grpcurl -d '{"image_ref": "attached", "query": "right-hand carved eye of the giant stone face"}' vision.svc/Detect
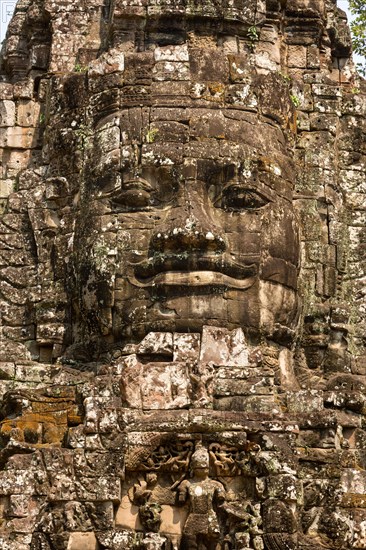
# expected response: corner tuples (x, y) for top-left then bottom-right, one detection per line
(215, 183), (269, 212)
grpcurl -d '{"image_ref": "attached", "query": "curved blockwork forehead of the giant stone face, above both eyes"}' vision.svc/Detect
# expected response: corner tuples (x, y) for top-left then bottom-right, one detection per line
(87, 106), (294, 204)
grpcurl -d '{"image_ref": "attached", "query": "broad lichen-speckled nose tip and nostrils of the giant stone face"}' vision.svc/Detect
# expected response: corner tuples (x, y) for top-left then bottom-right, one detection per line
(150, 215), (226, 256)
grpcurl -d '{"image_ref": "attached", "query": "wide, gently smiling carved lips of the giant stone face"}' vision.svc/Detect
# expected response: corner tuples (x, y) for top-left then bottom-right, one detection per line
(128, 254), (258, 290)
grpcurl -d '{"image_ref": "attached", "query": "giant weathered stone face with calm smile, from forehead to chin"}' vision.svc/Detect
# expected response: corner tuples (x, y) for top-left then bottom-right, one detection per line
(67, 59), (299, 350)
